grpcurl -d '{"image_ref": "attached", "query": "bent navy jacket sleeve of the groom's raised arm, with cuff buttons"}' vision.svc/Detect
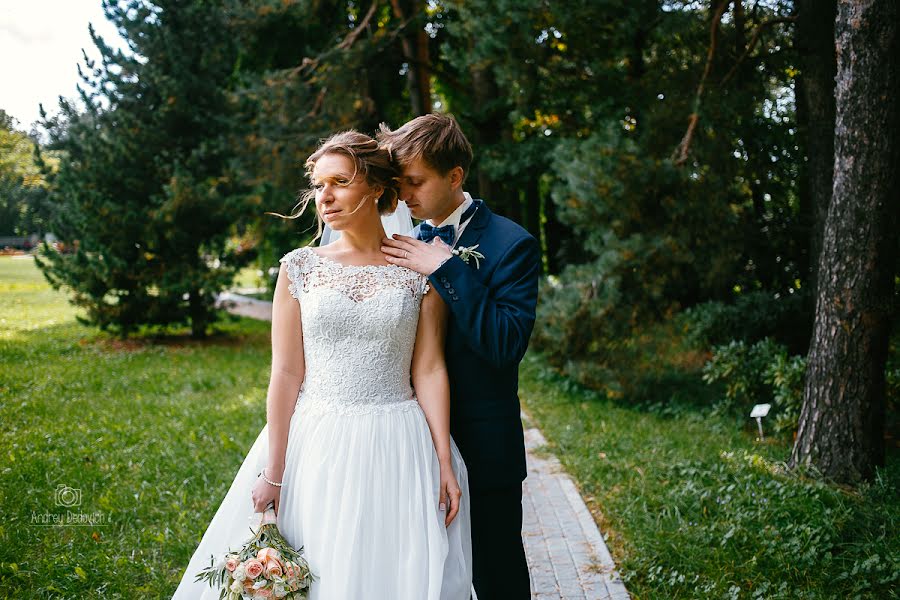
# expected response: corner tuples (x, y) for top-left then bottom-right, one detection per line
(429, 236), (541, 367)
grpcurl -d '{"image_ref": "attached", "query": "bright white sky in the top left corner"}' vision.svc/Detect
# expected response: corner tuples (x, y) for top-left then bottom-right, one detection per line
(0, 0), (124, 131)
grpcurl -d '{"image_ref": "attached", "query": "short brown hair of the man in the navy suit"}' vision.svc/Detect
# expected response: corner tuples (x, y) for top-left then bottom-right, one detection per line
(376, 113), (472, 181)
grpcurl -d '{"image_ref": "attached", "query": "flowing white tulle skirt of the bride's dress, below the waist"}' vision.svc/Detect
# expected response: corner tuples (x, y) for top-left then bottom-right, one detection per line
(173, 399), (472, 600)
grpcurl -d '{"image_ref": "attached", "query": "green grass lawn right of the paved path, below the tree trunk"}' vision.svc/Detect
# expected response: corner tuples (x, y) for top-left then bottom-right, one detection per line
(521, 355), (900, 599)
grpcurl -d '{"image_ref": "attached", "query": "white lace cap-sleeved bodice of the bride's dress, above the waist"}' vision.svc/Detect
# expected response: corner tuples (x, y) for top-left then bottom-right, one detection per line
(280, 248), (428, 413)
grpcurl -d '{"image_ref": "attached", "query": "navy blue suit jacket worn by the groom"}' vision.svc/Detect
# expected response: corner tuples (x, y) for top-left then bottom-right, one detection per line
(413, 200), (541, 489)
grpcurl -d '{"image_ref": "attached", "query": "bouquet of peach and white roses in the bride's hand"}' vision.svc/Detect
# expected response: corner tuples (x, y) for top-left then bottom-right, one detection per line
(196, 508), (314, 600)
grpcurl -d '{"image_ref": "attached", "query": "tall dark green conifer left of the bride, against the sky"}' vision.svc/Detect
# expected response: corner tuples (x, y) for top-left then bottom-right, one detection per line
(38, 0), (252, 337)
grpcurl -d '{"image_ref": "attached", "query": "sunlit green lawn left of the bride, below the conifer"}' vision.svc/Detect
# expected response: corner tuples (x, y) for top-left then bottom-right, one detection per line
(0, 257), (269, 598)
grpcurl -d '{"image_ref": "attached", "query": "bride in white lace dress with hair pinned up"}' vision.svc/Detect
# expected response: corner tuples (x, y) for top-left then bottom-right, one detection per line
(174, 131), (472, 600)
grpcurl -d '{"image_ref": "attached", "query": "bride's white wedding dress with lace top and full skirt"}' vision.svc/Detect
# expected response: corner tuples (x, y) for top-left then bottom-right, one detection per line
(174, 248), (472, 600)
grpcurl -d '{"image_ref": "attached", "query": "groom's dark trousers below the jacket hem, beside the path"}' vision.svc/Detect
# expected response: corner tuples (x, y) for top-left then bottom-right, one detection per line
(469, 483), (531, 600)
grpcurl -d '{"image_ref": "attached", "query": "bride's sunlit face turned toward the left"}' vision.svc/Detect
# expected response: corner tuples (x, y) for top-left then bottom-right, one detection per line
(312, 154), (381, 231)
